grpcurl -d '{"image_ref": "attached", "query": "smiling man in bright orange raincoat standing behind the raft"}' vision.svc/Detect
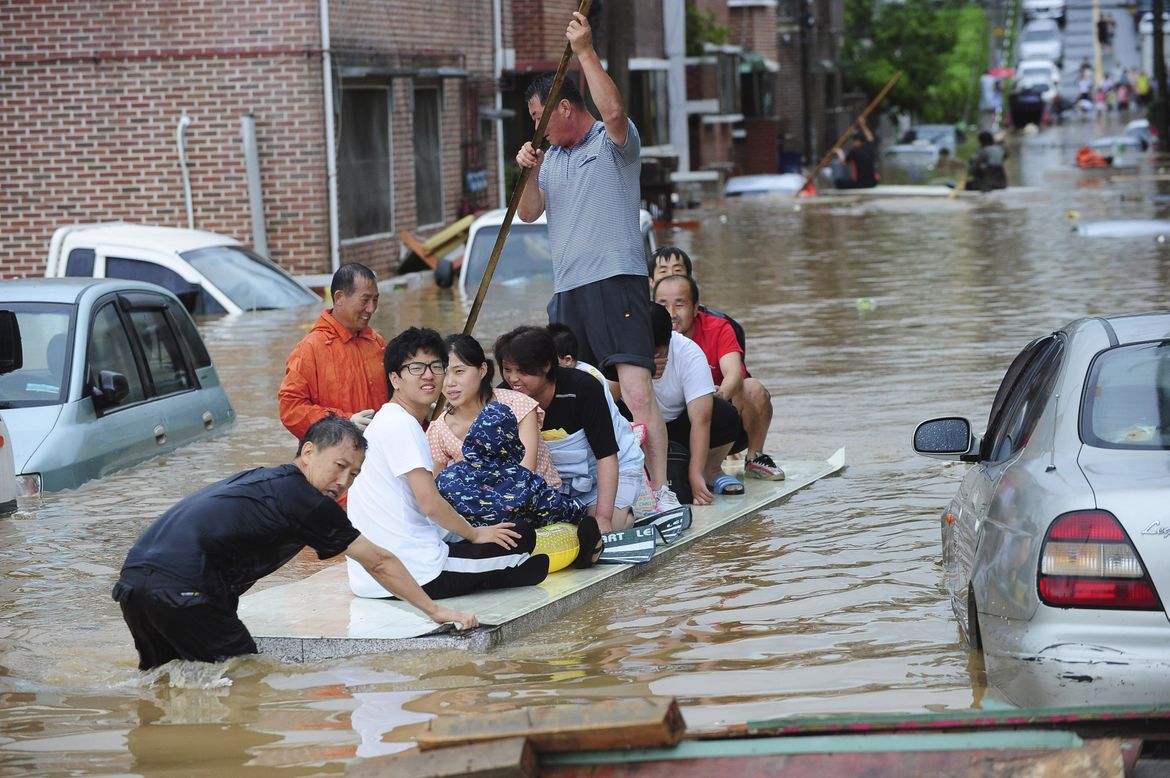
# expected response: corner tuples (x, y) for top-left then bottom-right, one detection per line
(277, 262), (390, 440)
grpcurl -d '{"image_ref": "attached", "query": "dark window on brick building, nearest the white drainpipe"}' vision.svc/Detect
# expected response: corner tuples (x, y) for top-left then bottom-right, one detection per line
(337, 87), (393, 239)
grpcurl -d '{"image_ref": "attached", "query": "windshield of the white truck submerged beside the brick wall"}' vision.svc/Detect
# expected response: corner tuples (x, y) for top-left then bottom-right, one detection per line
(183, 246), (321, 311)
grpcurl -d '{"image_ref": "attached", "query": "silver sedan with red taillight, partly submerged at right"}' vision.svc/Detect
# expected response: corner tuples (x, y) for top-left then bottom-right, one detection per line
(914, 314), (1170, 704)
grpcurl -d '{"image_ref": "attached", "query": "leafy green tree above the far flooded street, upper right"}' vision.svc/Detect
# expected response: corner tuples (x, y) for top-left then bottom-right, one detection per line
(841, 0), (987, 122)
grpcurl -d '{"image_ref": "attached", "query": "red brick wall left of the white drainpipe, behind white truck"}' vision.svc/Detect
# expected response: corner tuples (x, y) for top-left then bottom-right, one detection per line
(0, 0), (328, 277)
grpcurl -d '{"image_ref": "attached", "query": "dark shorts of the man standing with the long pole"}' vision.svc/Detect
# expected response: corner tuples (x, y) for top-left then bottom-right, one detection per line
(549, 276), (654, 380)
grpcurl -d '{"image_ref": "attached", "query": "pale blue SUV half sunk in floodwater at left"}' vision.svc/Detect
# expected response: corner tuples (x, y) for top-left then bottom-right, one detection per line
(0, 278), (235, 496)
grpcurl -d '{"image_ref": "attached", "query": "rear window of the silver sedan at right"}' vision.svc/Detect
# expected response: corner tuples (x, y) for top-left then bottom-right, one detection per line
(1081, 342), (1170, 449)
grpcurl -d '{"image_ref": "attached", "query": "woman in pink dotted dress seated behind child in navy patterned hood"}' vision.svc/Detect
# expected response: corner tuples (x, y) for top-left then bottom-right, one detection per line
(427, 335), (560, 489)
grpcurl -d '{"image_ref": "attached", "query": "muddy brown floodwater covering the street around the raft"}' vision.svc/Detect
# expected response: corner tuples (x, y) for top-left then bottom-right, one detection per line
(0, 115), (1170, 776)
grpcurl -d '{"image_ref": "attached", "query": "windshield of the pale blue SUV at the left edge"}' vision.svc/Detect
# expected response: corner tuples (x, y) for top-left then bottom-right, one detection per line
(0, 303), (75, 408)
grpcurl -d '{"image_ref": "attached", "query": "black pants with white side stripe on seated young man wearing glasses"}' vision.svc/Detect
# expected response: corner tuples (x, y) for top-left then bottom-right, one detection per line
(422, 524), (549, 600)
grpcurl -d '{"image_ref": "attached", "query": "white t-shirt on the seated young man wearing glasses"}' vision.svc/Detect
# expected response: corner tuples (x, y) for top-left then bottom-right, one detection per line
(345, 402), (448, 597)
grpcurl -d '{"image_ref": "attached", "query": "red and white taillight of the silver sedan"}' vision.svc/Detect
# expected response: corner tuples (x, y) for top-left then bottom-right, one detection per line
(1039, 510), (1162, 611)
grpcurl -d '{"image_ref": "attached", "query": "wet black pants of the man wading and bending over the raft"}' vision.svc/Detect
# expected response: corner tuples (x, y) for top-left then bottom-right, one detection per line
(113, 571), (257, 670)
